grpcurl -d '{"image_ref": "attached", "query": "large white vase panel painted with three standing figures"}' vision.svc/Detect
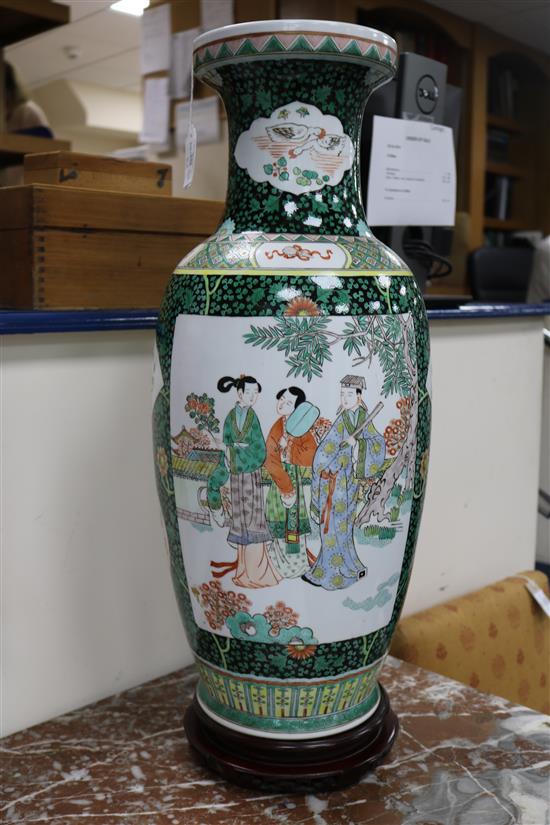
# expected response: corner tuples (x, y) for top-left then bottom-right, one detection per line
(171, 314), (418, 649)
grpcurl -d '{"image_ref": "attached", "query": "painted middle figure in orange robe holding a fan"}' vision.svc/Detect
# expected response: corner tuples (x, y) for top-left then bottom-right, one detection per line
(265, 387), (317, 579)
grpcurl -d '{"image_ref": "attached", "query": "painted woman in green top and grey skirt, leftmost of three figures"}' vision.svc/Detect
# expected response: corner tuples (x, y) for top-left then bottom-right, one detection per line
(212, 375), (280, 587)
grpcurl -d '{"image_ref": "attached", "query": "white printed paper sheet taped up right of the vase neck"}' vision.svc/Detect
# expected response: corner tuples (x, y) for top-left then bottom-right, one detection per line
(367, 115), (456, 226)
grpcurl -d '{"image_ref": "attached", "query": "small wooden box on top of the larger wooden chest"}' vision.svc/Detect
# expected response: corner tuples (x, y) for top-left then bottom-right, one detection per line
(24, 152), (172, 197)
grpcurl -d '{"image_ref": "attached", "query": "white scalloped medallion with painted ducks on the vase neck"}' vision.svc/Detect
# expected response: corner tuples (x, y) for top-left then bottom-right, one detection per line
(235, 101), (353, 195)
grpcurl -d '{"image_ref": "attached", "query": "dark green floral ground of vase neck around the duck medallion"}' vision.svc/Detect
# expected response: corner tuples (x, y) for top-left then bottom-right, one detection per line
(209, 59), (386, 233)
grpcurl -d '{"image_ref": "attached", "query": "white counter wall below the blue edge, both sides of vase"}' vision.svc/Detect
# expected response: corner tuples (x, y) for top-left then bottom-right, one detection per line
(0, 318), (542, 734)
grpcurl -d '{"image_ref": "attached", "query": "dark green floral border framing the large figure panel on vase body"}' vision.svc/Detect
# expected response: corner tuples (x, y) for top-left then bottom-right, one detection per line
(154, 273), (431, 679)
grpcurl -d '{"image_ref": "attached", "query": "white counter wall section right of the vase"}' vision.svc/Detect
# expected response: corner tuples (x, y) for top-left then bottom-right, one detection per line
(404, 317), (544, 615)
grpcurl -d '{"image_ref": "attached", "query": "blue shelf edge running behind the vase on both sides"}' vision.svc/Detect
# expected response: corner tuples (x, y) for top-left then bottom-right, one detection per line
(0, 303), (550, 335)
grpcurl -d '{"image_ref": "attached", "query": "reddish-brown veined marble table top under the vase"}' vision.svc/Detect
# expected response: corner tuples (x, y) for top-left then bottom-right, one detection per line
(0, 658), (550, 825)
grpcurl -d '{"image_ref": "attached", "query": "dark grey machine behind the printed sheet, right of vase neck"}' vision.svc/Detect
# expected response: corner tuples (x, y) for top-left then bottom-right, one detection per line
(361, 52), (462, 289)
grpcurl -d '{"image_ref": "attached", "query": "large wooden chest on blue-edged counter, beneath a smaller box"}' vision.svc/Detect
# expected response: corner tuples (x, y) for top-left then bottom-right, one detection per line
(0, 185), (223, 309)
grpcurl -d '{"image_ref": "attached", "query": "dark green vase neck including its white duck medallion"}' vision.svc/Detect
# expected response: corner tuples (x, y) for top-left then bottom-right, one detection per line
(203, 57), (388, 236)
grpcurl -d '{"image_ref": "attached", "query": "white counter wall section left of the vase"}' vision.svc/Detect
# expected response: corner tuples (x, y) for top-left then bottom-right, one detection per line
(0, 331), (191, 733)
